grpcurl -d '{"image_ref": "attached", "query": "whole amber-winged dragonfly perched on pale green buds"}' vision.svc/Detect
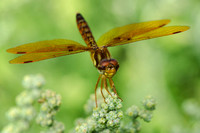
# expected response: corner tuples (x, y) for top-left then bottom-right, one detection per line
(7, 13), (190, 107)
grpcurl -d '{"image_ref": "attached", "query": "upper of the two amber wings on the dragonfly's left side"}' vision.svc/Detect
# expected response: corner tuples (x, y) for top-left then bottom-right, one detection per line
(7, 39), (87, 54)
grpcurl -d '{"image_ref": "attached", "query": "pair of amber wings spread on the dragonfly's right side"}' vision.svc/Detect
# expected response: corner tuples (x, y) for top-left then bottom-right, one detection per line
(97, 20), (189, 47)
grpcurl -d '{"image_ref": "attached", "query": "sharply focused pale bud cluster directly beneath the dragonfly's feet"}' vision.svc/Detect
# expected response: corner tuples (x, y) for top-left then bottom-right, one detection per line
(92, 93), (123, 132)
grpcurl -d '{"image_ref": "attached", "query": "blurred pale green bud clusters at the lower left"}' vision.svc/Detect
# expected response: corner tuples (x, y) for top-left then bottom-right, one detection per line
(1, 75), (65, 133)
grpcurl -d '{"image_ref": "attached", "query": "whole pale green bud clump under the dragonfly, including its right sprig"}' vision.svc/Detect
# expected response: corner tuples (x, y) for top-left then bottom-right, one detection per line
(72, 93), (156, 133)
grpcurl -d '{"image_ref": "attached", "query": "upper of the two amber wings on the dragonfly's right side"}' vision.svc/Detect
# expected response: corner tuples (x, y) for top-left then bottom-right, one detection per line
(97, 19), (170, 47)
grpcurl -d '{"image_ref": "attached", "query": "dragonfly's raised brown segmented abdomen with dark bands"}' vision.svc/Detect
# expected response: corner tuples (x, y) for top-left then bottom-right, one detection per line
(76, 13), (97, 48)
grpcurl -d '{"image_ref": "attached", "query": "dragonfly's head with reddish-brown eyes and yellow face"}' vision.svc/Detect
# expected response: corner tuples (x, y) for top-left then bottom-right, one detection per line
(98, 59), (119, 78)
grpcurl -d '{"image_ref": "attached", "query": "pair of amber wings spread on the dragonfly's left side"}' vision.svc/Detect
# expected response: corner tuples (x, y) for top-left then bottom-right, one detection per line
(7, 39), (89, 64)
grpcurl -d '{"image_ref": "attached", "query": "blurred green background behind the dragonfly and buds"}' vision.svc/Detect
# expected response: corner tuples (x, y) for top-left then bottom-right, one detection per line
(0, 0), (200, 133)
